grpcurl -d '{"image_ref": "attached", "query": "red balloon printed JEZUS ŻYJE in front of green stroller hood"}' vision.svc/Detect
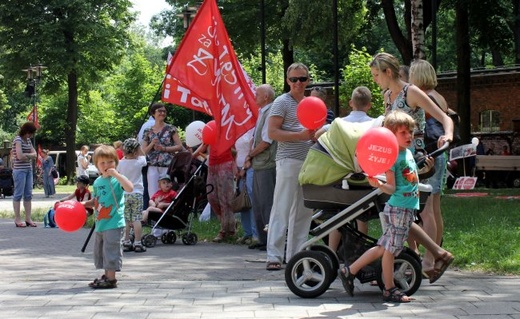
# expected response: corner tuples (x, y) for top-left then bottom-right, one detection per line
(356, 127), (399, 176)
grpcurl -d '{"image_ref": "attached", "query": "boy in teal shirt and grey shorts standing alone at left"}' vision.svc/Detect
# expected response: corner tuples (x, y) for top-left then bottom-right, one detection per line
(83, 145), (134, 289)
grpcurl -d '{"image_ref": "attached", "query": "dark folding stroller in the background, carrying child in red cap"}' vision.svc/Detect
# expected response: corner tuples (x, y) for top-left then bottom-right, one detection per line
(142, 152), (213, 247)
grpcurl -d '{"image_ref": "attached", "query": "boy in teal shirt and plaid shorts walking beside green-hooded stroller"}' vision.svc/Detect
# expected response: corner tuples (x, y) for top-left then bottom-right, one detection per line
(338, 111), (419, 302)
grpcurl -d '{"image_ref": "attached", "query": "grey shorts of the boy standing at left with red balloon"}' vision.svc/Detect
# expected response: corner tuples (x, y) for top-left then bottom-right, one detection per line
(94, 227), (124, 271)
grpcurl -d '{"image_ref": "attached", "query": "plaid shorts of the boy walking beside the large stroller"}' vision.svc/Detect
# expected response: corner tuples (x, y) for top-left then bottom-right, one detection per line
(377, 203), (415, 256)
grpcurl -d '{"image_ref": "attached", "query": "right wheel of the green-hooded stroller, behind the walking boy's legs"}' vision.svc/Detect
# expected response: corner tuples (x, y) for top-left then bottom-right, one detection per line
(377, 250), (422, 296)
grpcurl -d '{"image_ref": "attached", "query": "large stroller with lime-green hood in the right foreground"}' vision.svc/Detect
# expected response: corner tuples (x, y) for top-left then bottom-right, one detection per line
(285, 121), (448, 298)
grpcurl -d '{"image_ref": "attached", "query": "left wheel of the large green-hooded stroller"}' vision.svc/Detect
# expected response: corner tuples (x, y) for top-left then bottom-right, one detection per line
(285, 250), (332, 298)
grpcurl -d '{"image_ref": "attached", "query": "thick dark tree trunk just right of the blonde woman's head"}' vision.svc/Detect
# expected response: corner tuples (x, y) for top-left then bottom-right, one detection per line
(455, 0), (471, 144)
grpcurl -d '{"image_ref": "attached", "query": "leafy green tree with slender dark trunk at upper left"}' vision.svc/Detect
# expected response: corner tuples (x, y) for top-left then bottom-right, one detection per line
(0, 0), (134, 179)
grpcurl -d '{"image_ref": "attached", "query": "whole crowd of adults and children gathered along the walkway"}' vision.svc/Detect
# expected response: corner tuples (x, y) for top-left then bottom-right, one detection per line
(7, 53), (453, 302)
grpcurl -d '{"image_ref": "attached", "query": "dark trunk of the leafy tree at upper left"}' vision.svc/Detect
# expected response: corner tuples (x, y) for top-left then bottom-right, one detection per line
(65, 70), (78, 182)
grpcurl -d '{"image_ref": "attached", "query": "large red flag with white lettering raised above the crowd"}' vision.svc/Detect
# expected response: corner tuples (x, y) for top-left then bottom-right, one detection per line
(162, 0), (258, 154)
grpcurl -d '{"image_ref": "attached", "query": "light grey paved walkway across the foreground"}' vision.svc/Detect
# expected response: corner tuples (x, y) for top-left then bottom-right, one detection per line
(0, 196), (520, 319)
